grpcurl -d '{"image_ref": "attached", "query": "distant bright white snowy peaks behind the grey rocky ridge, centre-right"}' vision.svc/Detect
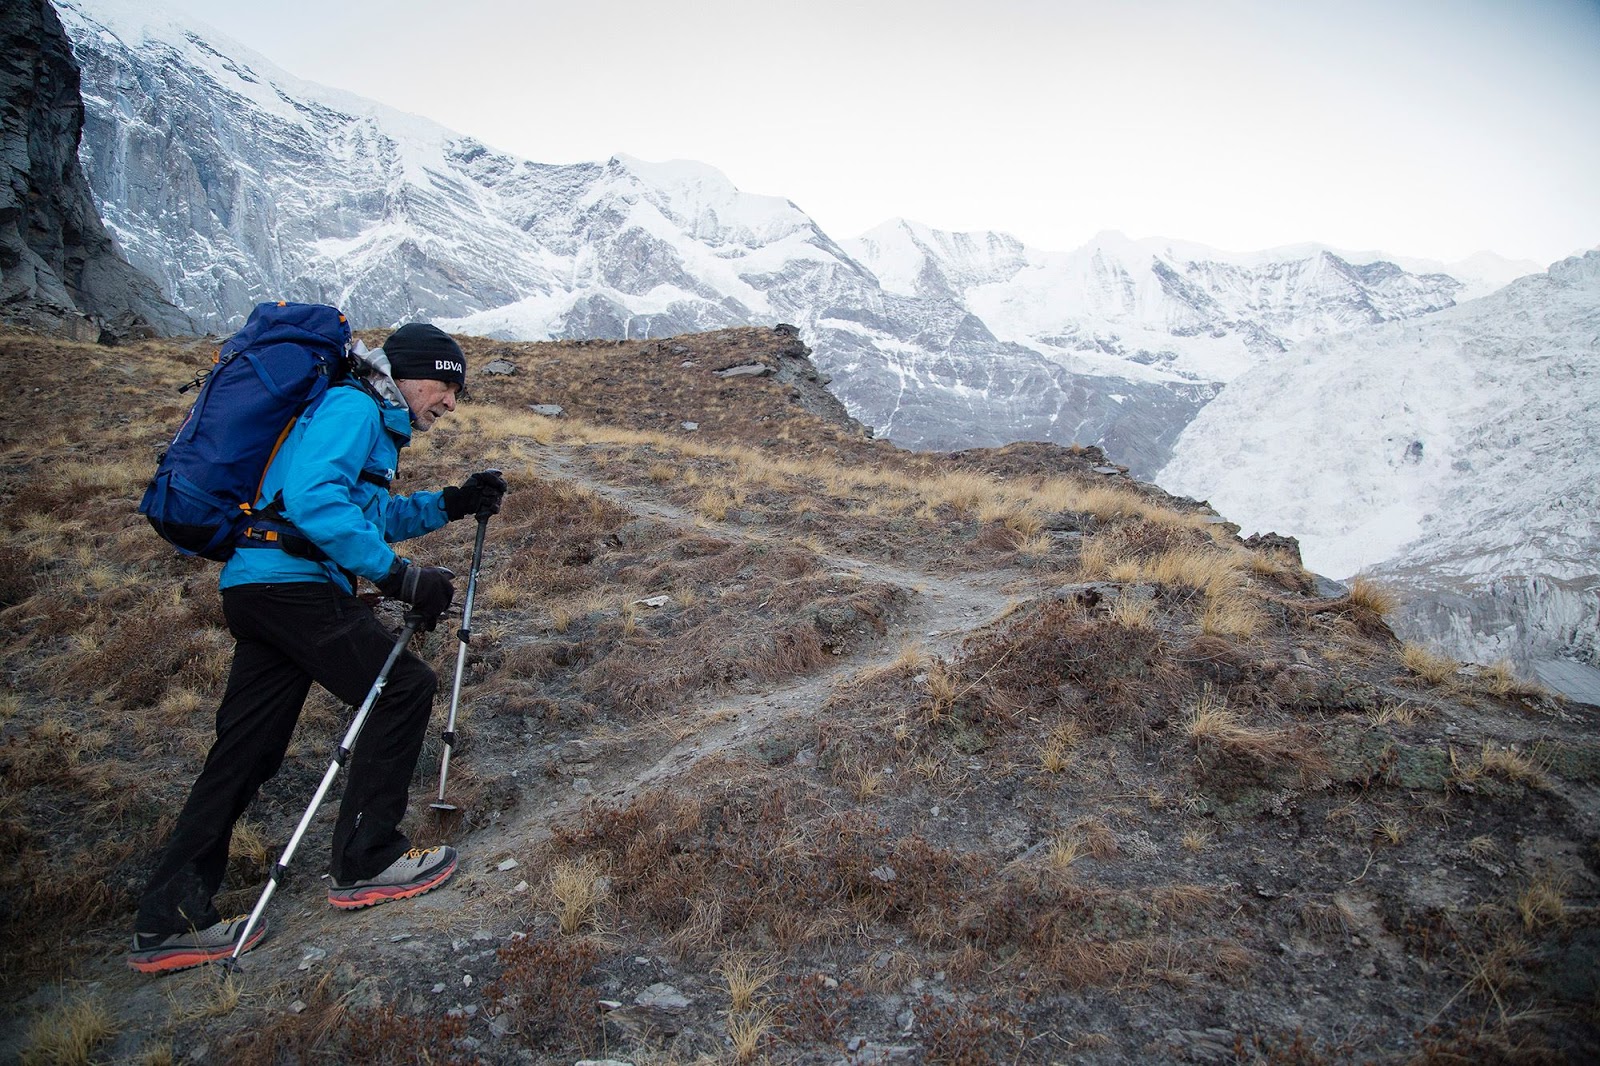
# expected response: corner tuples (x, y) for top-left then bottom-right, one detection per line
(842, 219), (1538, 383)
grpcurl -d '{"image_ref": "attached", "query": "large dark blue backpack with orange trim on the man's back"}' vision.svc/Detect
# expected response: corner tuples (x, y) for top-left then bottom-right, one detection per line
(139, 303), (352, 562)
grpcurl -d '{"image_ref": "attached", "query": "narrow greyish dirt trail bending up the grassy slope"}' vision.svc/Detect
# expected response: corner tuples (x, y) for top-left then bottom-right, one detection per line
(34, 445), (1014, 1045)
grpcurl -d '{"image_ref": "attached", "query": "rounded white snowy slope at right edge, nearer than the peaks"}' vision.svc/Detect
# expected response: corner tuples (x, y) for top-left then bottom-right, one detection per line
(1157, 250), (1600, 664)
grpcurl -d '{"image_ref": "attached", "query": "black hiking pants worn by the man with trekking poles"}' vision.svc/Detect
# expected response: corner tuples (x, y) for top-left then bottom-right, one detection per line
(134, 583), (438, 933)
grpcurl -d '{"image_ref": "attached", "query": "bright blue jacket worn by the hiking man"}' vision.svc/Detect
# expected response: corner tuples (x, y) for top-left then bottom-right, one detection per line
(221, 383), (450, 592)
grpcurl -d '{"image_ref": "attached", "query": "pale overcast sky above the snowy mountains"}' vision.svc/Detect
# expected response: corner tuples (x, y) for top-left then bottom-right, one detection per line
(152, 0), (1600, 264)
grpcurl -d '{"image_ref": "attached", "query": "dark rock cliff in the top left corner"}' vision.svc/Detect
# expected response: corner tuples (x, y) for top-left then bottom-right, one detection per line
(0, 0), (192, 343)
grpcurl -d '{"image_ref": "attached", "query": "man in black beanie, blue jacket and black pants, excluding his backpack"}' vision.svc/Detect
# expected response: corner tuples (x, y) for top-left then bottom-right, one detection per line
(128, 323), (506, 973)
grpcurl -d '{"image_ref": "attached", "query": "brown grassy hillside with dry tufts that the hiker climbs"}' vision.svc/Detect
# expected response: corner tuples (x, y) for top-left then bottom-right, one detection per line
(0, 328), (1600, 1064)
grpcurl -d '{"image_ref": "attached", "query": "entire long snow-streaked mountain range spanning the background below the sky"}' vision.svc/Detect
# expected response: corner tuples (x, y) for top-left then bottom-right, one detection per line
(58, 0), (1538, 474)
